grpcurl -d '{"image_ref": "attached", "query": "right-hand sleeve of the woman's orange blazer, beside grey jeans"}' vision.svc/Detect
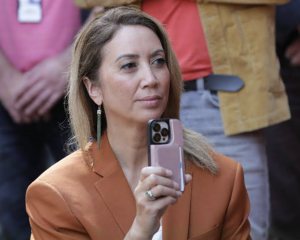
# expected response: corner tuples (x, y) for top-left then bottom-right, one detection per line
(221, 163), (251, 240)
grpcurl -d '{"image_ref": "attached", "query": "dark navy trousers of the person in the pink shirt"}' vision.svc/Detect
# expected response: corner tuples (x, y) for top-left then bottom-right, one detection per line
(0, 102), (68, 240)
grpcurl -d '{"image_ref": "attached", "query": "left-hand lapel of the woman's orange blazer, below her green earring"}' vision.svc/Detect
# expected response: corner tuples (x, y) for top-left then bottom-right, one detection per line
(91, 133), (136, 236)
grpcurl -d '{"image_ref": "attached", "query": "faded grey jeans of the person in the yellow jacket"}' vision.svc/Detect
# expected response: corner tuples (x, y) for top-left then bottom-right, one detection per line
(180, 79), (270, 240)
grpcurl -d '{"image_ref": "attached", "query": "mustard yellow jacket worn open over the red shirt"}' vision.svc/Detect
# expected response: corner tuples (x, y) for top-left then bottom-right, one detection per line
(74, 0), (290, 135)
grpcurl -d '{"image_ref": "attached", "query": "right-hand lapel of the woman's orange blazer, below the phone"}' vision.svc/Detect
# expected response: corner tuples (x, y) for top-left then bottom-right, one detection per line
(162, 167), (192, 240)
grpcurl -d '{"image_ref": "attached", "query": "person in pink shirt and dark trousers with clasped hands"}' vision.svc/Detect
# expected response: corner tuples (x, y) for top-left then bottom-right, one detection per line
(0, 0), (81, 240)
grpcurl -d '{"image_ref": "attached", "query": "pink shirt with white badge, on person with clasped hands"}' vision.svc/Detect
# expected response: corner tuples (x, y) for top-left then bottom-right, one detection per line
(0, 0), (81, 72)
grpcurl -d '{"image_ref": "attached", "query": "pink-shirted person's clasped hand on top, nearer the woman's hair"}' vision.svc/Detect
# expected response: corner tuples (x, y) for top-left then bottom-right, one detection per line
(16, 49), (70, 119)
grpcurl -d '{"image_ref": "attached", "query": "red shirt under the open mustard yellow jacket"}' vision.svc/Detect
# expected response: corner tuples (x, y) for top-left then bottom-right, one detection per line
(142, 0), (212, 80)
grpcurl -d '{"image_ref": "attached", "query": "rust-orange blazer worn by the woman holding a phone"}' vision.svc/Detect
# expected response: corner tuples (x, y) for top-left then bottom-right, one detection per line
(26, 135), (251, 240)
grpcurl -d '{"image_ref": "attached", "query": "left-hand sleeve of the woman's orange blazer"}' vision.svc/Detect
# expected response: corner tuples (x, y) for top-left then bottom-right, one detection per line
(26, 180), (90, 240)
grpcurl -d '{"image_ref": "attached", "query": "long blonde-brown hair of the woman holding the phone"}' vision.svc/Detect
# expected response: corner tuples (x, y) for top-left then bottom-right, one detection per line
(68, 7), (218, 174)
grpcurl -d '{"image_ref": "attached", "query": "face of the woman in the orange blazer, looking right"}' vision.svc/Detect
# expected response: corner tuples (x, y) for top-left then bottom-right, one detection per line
(99, 25), (170, 124)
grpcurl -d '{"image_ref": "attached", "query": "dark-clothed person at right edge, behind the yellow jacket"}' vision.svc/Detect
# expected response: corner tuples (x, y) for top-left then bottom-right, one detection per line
(265, 0), (300, 240)
